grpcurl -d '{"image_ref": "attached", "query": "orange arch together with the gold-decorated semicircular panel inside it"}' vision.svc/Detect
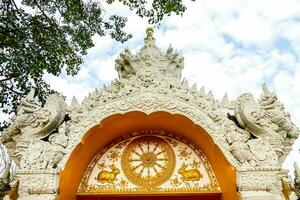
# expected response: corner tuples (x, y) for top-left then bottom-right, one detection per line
(59, 112), (237, 200)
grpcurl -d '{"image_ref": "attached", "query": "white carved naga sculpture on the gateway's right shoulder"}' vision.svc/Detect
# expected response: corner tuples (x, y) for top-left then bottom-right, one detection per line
(235, 84), (299, 162)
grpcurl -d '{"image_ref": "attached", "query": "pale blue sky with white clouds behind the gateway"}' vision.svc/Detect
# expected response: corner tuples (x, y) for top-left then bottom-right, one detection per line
(4, 0), (300, 177)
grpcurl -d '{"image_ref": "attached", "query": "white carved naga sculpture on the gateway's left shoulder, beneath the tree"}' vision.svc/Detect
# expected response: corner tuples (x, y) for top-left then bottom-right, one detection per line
(1, 90), (67, 161)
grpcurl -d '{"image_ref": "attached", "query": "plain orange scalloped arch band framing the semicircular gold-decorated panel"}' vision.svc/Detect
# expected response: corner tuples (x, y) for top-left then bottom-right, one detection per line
(57, 111), (239, 200)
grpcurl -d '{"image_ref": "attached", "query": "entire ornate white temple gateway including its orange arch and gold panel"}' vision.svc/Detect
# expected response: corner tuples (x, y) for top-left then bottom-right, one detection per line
(2, 28), (300, 200)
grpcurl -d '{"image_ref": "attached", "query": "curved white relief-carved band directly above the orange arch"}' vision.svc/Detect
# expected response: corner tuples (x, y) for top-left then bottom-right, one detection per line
(60, 91), (240, 170)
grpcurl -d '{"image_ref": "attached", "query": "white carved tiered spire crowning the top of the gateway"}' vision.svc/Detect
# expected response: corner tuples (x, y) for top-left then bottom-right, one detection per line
(115, 27), (184, 81)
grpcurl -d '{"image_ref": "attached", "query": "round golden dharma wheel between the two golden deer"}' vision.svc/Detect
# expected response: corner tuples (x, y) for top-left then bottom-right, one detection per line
(121, 136), (176, 187)
